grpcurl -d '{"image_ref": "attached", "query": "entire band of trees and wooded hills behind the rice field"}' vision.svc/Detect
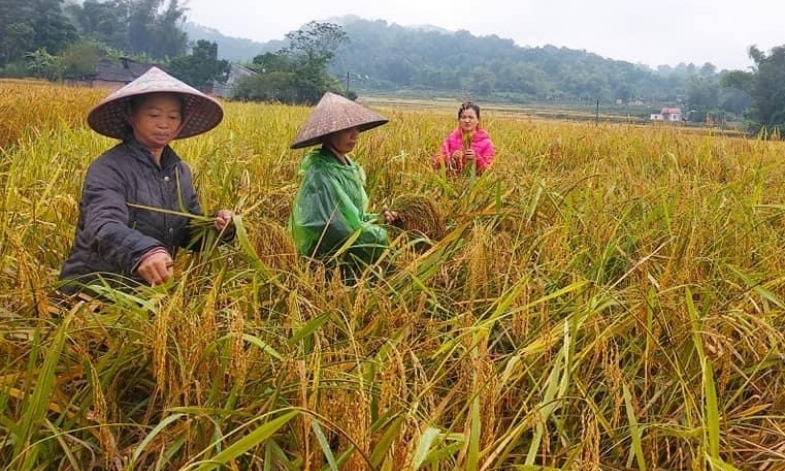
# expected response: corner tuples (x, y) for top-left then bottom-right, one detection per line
(0, 0), (785, 133)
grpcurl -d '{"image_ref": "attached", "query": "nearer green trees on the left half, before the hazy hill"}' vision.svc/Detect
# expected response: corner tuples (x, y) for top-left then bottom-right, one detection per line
(0, 0), (346, 103)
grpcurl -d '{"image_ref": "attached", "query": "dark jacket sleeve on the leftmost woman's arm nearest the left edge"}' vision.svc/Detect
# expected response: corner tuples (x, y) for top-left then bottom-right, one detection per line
(81, 160), (168, 275)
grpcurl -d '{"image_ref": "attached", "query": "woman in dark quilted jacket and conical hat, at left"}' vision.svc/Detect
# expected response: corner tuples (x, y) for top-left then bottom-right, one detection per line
(60, 67), (233, 293)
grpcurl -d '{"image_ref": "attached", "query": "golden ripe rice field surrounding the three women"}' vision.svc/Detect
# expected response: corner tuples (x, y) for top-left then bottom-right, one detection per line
(0, 82), (785, 471)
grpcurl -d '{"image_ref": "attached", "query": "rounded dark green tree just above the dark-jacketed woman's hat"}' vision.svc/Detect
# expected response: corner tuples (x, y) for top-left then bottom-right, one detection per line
(167, 40), (229, 91)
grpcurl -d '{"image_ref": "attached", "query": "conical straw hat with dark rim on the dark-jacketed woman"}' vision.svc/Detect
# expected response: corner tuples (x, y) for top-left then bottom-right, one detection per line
(87, 67), (223, 139)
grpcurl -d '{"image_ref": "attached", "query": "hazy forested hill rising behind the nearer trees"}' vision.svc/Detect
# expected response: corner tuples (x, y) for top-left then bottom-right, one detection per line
(188, 17), (717, 104)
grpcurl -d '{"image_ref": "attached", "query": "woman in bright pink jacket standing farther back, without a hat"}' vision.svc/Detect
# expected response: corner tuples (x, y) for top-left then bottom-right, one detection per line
(432, 101), (495, 175)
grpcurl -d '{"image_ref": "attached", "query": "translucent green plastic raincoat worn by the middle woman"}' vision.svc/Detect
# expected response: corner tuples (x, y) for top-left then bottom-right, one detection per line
(289, 147), (390, 263)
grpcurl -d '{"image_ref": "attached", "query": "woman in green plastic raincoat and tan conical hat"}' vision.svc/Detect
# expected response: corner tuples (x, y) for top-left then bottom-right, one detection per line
(289, 92), (397, 276)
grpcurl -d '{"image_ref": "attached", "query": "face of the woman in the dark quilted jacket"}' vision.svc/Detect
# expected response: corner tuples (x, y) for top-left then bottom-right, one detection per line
(131, 93), (183, 150)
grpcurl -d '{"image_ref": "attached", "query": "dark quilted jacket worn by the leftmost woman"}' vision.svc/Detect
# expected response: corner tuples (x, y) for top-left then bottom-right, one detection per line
(60, 139), (202, 291)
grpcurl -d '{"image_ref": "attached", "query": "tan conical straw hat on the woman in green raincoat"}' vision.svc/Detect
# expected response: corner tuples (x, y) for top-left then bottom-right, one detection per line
(291, 92), (387, 149)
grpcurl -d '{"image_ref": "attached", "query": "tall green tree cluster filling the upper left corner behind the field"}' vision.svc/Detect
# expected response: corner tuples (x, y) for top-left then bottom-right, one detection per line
(0, 0), (229, 88)
